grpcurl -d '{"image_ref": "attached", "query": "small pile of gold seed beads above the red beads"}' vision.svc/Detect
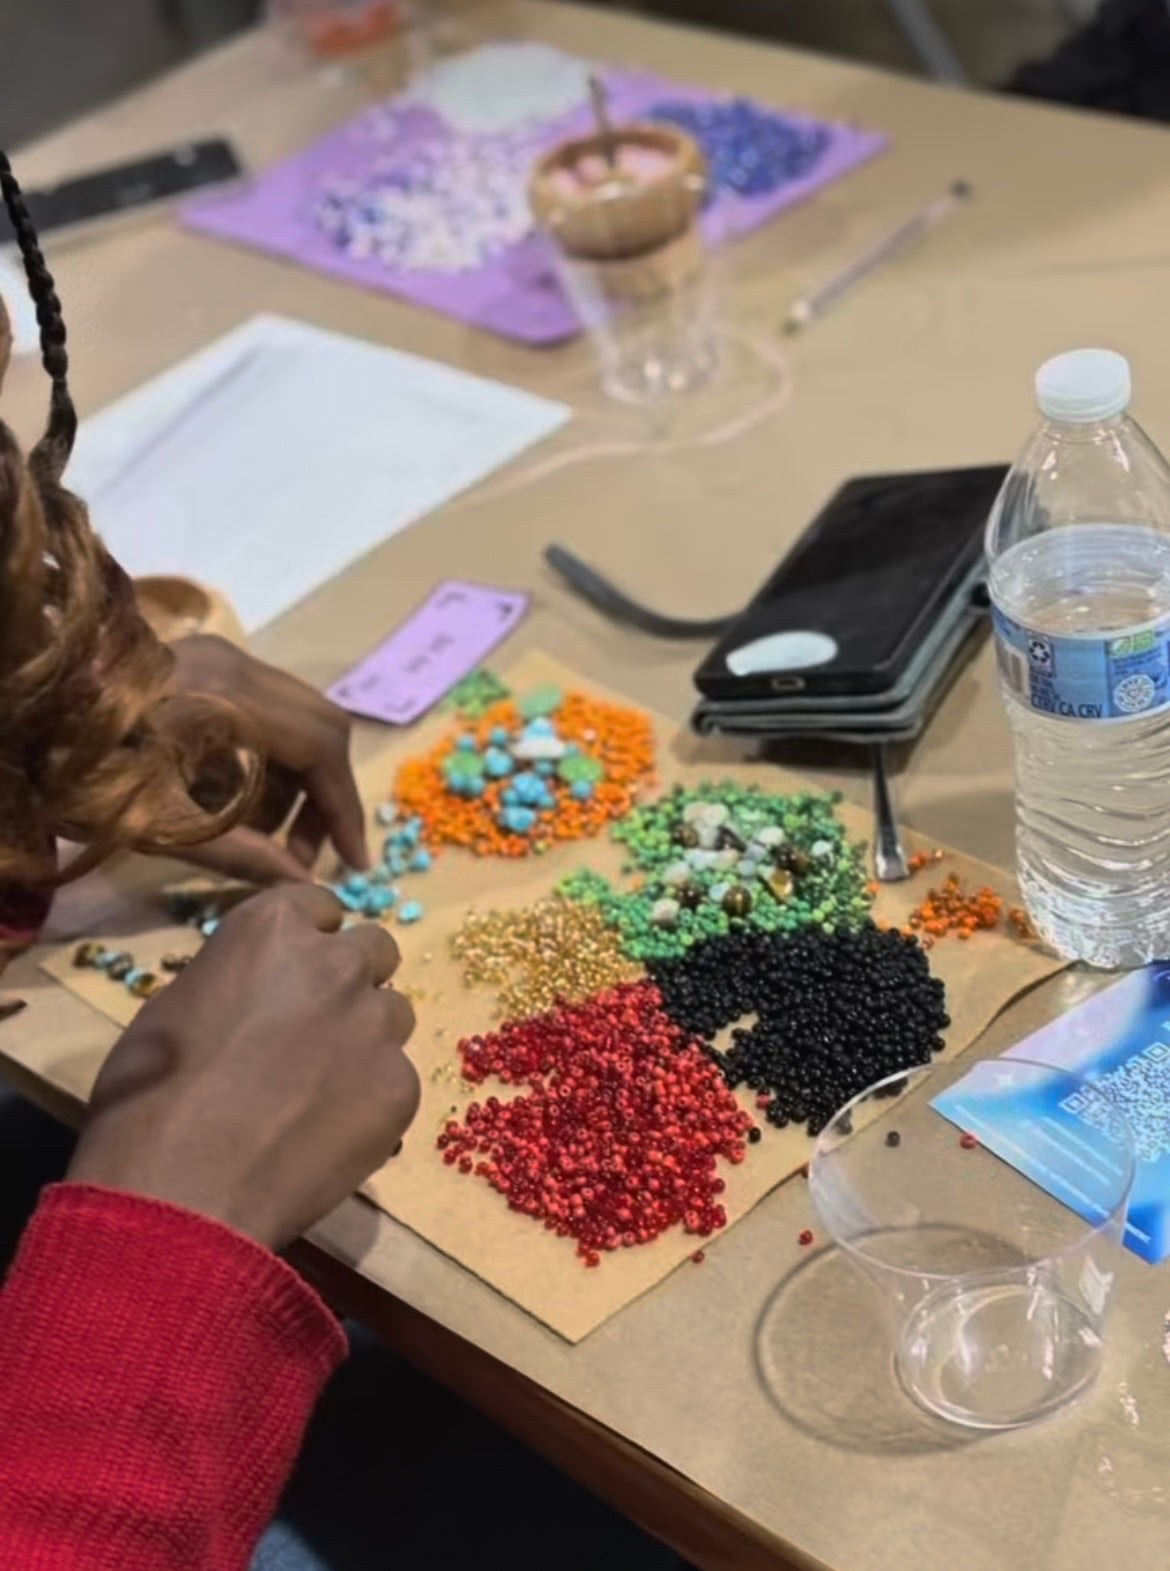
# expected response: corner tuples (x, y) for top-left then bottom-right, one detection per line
(451, 895), (642, 1020)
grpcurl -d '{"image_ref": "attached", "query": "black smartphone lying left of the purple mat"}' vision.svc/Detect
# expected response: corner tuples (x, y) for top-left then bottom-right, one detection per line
(0, 137), (243, 245)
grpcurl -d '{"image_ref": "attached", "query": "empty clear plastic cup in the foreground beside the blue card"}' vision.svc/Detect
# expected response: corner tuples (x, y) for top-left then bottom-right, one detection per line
(809, 1059), (1134, 1430)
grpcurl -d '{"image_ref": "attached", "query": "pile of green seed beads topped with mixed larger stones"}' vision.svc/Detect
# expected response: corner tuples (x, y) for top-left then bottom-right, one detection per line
(561, 781), (872, 961)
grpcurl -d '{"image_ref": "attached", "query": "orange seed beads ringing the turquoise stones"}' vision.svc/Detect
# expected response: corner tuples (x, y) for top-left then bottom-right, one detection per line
(394, 693), (655, 856)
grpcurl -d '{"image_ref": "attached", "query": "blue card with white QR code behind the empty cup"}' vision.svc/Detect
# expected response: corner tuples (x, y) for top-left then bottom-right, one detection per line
(931, 961), (1170, 1265)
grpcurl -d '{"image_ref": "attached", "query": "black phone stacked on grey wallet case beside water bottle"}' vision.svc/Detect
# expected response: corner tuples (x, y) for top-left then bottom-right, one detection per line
(693, 465), (1005, 745)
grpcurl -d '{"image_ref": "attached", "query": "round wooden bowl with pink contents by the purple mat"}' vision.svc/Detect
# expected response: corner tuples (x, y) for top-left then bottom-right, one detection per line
(528, 124), (707, 262)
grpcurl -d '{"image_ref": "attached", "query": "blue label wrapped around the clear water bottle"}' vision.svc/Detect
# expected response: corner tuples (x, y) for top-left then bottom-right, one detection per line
(993, 606), (1170, 720)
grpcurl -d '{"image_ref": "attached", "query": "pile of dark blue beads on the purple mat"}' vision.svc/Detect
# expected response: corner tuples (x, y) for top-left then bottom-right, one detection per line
(642, 99), (831, 196)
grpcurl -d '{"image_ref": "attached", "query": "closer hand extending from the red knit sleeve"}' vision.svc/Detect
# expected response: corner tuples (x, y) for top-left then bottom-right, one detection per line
(69, 884), (419, 1249)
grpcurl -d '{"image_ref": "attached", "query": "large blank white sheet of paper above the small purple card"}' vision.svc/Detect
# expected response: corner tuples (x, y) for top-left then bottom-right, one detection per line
(68, 316), (570, 632)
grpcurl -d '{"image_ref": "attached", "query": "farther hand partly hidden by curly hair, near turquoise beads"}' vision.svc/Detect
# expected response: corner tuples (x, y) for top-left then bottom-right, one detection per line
(173, 633), (369, 883)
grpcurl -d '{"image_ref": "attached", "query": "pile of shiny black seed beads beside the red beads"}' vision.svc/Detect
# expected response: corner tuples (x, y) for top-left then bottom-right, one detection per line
(649, 922), (950, 1134)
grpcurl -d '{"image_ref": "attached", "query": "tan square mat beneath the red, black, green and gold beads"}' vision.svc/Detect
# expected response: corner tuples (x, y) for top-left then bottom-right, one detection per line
(44, 654), (1060, 1342)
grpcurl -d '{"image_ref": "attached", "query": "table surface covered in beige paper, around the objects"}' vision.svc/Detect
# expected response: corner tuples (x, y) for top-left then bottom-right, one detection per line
(3, 5), (1170, 1571)
